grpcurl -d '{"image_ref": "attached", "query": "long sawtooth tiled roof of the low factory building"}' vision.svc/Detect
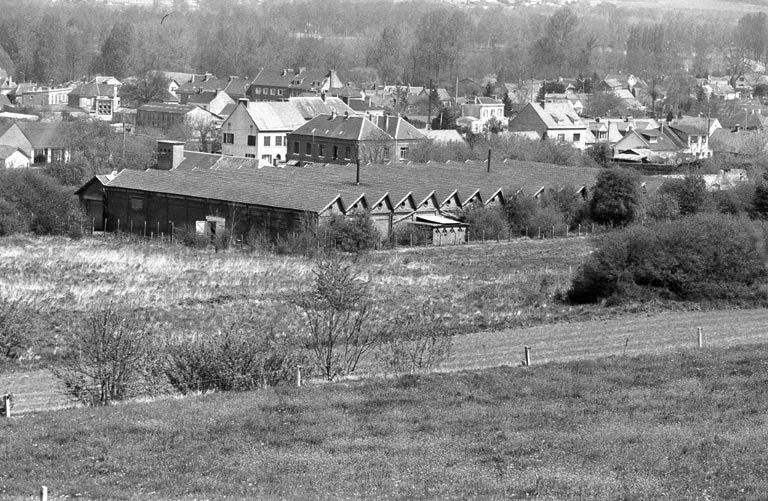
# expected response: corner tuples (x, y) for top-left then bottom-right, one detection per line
(100, 152), (599, 212)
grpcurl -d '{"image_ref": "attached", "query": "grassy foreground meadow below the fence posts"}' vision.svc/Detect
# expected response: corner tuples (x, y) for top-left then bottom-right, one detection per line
(0, 345), (768, 499)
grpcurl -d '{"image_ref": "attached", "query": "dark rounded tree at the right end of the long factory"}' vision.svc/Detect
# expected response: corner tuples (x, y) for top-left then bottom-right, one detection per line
(589, 168), (641, 226)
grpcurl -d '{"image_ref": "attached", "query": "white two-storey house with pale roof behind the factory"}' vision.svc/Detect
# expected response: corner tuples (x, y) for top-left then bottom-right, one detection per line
(221, 99), (306, 165)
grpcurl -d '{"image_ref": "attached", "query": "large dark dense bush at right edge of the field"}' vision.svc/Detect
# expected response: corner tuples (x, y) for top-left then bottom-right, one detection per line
(568, 214), (768, 303)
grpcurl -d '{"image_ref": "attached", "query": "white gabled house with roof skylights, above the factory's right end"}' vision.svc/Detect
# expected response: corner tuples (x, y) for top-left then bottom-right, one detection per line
(509, 103), (591, 150)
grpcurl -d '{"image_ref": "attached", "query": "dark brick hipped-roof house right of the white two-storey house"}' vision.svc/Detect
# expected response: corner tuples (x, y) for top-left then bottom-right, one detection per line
(288, 113), (394, 164)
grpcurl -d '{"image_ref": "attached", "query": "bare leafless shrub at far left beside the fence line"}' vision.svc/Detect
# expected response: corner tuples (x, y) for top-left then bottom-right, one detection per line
(56, 304), (154, 405)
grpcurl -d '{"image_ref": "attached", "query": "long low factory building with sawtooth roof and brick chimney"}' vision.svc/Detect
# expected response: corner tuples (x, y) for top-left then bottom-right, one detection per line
(77, 140), (599, 245)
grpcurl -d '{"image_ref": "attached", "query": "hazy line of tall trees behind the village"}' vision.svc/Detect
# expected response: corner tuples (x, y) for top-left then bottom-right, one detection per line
(0, 0), (768, 90)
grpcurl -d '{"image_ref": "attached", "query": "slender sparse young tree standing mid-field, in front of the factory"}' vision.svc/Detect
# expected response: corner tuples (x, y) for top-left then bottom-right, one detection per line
(290, 257), (381, 381)
